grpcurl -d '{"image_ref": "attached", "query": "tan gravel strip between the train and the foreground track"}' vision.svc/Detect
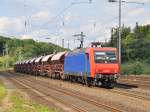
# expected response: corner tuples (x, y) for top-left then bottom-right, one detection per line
(31, 76), (150, 112)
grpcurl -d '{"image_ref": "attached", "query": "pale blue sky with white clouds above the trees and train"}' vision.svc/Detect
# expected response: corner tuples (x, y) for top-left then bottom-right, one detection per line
(0, 0), (150, 49)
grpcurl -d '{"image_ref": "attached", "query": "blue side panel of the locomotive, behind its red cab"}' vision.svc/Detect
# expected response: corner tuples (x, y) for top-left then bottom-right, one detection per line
(64, 52), (90, 77)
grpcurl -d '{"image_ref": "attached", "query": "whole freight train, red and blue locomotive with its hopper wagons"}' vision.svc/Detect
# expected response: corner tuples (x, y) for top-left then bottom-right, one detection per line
(14, 47), (120, 88)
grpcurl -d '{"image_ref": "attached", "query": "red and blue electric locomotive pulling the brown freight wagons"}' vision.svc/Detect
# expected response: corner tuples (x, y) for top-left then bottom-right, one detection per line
(64, 47), (120, 88)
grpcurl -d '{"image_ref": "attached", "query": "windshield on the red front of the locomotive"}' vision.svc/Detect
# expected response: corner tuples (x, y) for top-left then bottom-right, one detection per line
(94, 51), (117, 63)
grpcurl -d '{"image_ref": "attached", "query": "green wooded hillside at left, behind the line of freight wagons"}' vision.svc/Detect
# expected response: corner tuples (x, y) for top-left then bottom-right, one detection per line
(0, 36), (67, 69)
